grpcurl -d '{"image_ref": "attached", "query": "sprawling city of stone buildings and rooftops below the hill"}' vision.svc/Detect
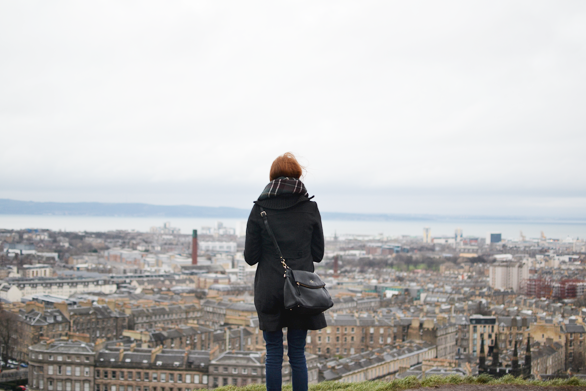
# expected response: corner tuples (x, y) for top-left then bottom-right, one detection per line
(0, 223), (586, 391)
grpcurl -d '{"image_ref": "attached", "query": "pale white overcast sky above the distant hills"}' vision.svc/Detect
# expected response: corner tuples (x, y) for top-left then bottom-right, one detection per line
(0, 0), (586, 217)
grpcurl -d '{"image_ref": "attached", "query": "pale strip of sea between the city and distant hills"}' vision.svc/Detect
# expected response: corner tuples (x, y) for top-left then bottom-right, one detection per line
(0, 214), (586, 240)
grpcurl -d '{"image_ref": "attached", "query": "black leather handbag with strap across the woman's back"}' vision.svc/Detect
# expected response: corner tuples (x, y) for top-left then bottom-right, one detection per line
(260, 207), (334, 315)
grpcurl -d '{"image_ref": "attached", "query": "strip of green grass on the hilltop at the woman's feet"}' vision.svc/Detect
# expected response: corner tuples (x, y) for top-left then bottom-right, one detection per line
(216, 374), (586, 391)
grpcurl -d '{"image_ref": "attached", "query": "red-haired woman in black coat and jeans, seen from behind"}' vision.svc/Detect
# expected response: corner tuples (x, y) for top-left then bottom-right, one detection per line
(244, 153), (327, 391)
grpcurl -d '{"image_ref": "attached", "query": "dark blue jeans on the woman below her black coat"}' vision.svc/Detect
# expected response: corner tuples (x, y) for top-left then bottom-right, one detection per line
(263, 329), (308, 391)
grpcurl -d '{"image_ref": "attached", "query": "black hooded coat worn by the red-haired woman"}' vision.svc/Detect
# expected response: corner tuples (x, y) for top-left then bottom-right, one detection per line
(244, 194), (327, 331)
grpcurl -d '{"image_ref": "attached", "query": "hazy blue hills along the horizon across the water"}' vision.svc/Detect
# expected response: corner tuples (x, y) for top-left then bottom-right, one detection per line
(0, 199), (584, 224)
